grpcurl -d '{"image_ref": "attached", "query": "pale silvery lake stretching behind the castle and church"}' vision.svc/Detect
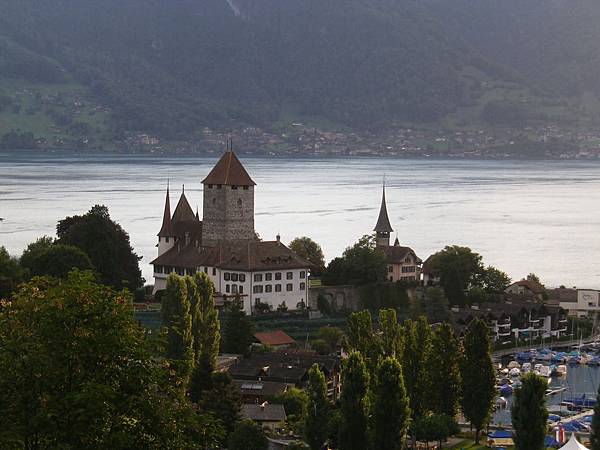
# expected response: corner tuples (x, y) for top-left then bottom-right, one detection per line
(0, 152), (600, 288)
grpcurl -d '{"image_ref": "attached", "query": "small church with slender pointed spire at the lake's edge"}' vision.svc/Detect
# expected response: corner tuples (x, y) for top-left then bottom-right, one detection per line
(373, 185), (422, 282)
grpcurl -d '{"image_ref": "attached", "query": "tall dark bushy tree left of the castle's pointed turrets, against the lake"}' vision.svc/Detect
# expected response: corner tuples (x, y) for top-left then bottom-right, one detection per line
(56, 205), (143, 291)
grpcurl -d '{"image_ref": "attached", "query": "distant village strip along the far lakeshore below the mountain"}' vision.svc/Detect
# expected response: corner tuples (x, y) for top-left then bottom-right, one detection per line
(126, 123), (600, 159)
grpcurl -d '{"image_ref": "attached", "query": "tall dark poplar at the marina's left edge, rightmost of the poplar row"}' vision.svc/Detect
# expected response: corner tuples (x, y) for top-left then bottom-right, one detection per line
(461, 318), (496, 443)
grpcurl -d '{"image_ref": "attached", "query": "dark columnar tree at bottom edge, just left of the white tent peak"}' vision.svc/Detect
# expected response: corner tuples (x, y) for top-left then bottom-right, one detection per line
(511, 373), (548, 450)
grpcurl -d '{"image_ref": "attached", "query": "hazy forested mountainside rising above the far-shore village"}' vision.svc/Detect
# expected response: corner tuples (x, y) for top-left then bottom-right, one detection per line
(0, 0), (600, 146)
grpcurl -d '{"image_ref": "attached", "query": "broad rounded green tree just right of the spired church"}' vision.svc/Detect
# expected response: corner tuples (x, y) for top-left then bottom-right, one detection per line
(429, 245), (483, 305)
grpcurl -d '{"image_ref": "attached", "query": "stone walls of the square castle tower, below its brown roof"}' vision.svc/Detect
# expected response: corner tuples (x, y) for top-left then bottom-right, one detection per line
(202, 185), (255, 246)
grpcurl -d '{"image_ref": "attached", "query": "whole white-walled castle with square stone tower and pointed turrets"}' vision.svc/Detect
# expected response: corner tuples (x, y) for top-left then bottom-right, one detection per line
(151, 150), (310, 314)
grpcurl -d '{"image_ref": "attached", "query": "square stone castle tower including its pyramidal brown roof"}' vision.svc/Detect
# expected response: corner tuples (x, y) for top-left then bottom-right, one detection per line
(202, 150), (256, 246)
